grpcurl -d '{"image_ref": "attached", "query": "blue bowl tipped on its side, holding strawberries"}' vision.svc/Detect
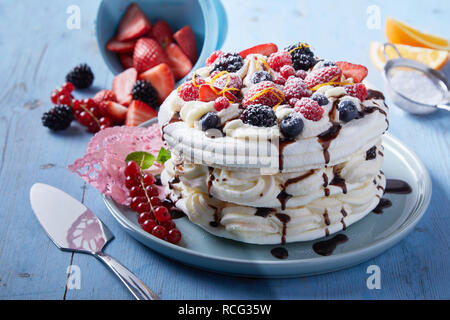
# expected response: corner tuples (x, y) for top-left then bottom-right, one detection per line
(96, 0), (228, 81)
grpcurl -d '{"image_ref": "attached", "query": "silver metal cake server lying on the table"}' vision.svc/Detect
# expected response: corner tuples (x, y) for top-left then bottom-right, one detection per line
(30, 183), (160, 300)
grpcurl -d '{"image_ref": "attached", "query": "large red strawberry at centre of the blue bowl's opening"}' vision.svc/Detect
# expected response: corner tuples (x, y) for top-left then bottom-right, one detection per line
(133, 38), (169, 73)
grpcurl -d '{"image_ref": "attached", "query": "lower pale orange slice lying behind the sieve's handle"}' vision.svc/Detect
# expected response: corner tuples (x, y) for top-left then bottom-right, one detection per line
(370, 42), (449, 70)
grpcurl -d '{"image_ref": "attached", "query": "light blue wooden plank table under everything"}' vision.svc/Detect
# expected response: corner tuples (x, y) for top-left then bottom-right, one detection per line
(0, 0), (450, 299)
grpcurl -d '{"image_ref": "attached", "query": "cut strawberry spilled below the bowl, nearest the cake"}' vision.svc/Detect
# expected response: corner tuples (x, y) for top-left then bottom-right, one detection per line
(139, 63), (175, 103)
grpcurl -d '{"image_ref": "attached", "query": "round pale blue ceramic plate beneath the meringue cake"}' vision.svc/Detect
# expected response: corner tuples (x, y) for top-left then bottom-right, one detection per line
(104, 121), (431, 278)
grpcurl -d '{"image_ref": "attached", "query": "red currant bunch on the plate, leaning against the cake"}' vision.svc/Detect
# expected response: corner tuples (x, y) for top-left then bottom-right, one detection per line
(124, 161), (181, 244)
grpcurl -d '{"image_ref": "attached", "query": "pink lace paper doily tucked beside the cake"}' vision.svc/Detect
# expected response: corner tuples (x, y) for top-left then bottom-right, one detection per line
(68, 124), (163, 205)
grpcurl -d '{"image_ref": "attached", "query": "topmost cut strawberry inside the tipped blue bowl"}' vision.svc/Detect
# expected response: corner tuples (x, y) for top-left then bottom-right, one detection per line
(117, 3), (152, 41)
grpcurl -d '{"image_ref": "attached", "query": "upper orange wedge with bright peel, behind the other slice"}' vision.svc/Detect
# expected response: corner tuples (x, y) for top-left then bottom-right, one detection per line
(386, 17), (450, 51)
